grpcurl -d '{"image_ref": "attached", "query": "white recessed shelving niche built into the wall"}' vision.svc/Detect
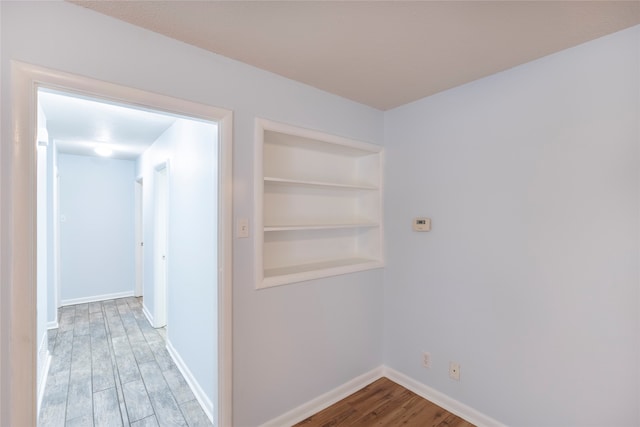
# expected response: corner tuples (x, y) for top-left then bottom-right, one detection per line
(255, 119), (383, 288)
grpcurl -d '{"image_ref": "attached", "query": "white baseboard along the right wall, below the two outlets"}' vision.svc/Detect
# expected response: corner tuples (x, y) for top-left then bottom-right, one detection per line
(383, 366), (506, 427)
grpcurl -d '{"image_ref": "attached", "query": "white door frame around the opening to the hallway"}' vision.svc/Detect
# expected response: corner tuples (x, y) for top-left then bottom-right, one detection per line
(0, 61), (233, 426)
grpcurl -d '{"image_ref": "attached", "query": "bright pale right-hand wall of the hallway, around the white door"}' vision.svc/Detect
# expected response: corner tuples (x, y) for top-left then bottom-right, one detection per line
(136, 119), (218, 410)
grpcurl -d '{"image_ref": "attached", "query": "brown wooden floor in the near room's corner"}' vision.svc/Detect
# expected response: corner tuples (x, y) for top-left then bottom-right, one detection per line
(293, 378), (474, 427)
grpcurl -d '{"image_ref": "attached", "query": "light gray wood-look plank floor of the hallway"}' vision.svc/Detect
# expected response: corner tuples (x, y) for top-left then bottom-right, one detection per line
(38, 297), (212, 427)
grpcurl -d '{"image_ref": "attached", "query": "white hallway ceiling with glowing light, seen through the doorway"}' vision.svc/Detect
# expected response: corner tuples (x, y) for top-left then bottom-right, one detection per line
(38, 89), (177, 160)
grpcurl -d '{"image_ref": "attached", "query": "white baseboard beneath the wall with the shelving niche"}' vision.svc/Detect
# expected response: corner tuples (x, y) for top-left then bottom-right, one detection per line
(261, 366), (384, 427)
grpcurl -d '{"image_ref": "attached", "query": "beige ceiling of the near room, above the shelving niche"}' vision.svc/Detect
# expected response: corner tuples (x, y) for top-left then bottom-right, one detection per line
(69, 0), (640, 110)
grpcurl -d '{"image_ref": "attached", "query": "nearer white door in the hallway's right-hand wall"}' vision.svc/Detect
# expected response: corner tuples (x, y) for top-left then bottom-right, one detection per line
(153, 163), (169, 328)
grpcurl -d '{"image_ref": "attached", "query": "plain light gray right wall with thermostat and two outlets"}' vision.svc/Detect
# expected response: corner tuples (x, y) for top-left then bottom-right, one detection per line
(385, 27), (640, 427)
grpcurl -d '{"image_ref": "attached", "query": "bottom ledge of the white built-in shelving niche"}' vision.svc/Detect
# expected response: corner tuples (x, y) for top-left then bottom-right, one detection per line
(260, 258), (384, 288)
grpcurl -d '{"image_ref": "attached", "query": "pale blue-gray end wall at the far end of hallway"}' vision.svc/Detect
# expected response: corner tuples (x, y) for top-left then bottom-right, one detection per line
(58, 154), (135, 304)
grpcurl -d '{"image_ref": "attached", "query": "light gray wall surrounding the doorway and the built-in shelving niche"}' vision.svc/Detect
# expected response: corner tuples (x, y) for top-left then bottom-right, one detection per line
(0, 2), (383, 426)
